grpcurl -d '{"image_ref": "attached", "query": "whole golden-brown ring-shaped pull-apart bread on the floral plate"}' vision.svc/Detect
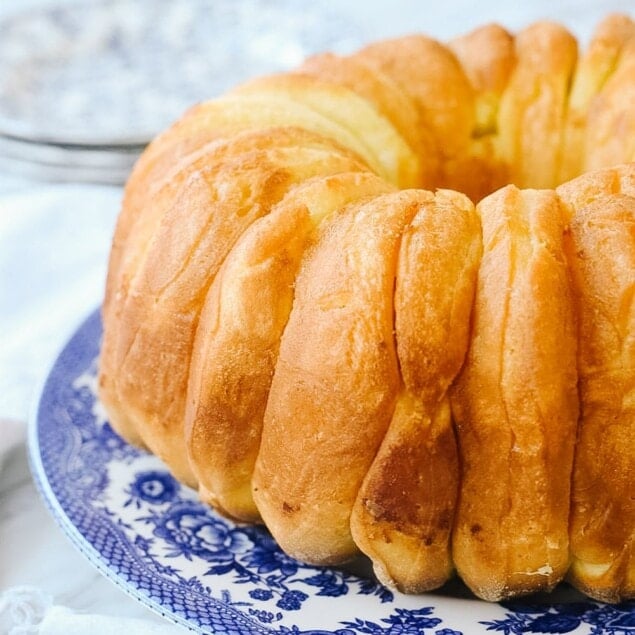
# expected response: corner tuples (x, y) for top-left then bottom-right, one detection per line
(99, 15), (635, 602)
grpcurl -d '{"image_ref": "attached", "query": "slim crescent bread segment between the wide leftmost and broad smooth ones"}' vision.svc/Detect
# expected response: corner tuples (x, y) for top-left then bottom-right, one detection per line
(186, 172), (391, 521)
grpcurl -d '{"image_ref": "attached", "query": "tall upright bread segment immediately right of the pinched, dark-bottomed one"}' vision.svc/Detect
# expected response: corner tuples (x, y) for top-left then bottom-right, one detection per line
(452, 186), (578, 600)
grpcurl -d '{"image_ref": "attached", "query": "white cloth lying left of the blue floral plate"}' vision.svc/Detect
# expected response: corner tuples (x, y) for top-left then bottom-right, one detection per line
(0, 186), (186, 635)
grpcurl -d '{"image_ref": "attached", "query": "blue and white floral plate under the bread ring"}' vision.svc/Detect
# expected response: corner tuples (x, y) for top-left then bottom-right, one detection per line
(29, 311), (635, 635)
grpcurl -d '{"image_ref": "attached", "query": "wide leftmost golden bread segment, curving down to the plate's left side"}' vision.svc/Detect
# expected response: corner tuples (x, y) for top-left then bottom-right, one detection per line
(102, 142), (363, 484)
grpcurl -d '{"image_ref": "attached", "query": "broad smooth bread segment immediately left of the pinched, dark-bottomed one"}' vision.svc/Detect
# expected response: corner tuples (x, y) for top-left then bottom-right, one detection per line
(253, 192), (417, 564)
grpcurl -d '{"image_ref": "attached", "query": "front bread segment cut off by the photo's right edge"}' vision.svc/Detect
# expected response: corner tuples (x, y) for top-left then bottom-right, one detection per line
(561, 170), (635, 602)
